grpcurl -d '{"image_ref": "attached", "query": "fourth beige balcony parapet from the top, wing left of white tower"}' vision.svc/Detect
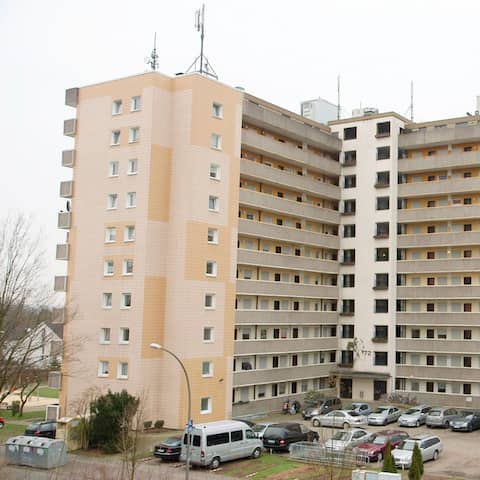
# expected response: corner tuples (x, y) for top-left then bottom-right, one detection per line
(240, 188), (340, 224)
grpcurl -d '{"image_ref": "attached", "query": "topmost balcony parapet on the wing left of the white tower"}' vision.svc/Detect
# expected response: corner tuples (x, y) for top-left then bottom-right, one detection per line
(243, 100), (342, 153)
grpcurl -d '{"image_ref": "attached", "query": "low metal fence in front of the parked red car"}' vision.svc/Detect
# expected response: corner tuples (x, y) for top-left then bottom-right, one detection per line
(290, 442), (369, 468)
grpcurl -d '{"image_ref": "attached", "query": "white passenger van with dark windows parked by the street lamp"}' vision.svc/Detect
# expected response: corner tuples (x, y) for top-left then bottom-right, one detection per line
(180, 420), (263, 469)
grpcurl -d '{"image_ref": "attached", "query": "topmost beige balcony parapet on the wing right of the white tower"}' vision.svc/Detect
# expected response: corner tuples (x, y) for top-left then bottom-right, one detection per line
(398, 124), (480, 150)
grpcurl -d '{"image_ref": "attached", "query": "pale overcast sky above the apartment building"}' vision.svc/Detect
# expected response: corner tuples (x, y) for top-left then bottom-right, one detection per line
(0, 0), (480, 283)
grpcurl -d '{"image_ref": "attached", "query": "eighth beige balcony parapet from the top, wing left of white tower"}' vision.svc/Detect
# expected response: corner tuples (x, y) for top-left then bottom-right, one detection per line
(235, 310), (338, 325)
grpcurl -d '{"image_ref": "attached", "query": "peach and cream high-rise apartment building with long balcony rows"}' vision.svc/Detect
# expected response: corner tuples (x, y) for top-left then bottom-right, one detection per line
(55, 68), (480, 427)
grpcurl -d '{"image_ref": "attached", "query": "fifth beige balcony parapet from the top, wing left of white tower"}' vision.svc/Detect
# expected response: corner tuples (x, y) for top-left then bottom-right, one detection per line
(238, 218), (340, 250)
